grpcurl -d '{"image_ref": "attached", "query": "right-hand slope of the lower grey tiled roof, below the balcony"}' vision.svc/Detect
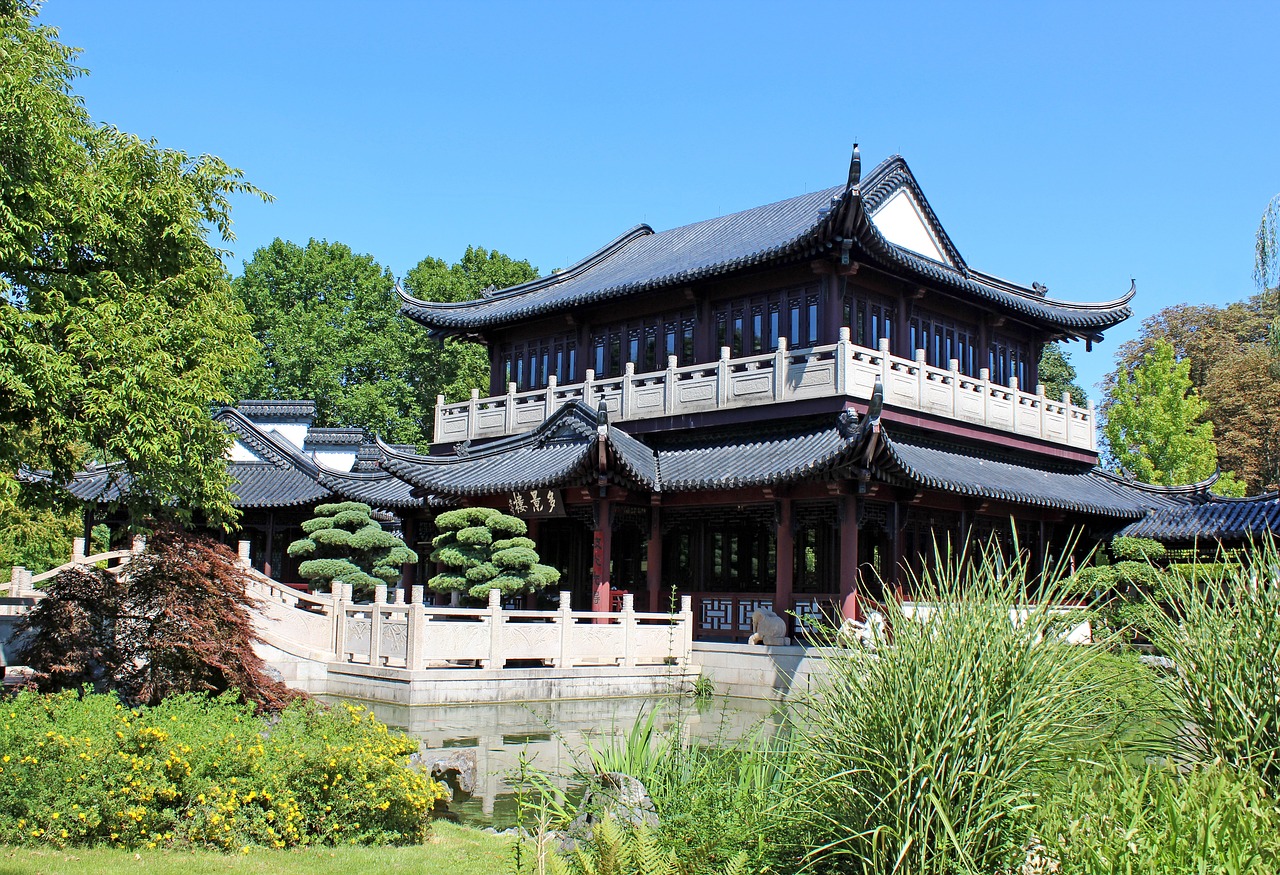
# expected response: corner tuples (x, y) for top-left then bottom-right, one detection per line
(877, 434), (1194, 519)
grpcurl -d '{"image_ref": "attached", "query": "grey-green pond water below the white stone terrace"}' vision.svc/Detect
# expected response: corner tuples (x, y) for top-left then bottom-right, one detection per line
(325, 696), (780, 829)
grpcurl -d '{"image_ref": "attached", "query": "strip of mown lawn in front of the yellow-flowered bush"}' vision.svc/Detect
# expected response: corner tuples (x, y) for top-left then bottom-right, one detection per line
(0, 821), (512, 875)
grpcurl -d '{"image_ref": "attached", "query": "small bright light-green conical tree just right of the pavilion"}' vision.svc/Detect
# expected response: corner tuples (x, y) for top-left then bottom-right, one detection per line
(1102, 340), (1239, 486)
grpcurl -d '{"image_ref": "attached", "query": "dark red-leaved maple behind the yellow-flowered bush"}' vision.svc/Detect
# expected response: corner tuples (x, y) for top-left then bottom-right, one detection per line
(18, 531), (297, 710)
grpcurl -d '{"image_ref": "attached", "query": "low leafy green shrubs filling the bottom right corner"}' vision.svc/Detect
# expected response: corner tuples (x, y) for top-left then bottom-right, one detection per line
(1037, 757), (1280, 875)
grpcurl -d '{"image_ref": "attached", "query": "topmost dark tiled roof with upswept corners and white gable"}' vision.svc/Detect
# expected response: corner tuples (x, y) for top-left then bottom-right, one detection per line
(401, 156), (1133, 336)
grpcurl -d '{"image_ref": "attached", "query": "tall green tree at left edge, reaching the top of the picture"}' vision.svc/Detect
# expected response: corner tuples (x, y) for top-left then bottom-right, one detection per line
(0, 0), (261, 522)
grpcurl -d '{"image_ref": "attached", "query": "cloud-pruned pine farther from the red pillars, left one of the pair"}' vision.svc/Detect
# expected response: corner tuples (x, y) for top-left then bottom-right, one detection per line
(289, 501), (417, 596)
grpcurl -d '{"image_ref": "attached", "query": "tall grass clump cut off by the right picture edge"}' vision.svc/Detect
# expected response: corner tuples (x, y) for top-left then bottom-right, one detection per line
(1152, 539), (1280, 792)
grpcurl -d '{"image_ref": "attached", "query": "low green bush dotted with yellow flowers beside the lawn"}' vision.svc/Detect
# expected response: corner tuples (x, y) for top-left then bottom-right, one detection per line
(0, 691), (444, 849)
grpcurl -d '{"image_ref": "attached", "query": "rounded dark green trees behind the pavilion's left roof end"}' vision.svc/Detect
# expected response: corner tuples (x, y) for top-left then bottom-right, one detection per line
(232, 239), (536, 449)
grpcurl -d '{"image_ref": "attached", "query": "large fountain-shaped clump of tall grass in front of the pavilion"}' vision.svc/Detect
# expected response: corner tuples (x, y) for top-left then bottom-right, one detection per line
(780, 545), (1117, 875)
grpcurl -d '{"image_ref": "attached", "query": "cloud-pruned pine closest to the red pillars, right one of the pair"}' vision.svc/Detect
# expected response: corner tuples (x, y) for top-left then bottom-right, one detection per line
(428, 508), (559, 599)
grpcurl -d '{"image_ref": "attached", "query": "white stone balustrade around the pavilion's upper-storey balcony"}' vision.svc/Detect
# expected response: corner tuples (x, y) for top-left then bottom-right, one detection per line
(435, 327), (1097, 452)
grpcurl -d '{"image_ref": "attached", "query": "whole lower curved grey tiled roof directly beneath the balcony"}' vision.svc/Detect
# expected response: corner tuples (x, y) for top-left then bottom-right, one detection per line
(380, 402), (1192, 519)
